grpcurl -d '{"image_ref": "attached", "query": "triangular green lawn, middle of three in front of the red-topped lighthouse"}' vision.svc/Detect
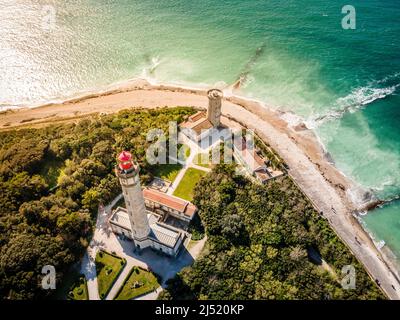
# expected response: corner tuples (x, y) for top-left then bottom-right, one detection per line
(96, 251), (126, 299)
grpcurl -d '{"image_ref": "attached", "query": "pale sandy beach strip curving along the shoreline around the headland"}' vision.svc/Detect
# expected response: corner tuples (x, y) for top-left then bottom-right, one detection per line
(0, 80), (400, 299)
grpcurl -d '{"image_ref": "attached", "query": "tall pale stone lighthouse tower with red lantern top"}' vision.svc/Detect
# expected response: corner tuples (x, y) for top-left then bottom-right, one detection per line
(115, 151), (150, 242)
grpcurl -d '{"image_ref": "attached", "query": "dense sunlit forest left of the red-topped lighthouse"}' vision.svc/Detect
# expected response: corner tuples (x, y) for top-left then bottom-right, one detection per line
(0, 108), (193, 299)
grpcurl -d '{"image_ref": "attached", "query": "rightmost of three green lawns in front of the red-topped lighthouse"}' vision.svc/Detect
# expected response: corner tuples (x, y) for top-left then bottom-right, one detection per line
(115, 267), (160, 300)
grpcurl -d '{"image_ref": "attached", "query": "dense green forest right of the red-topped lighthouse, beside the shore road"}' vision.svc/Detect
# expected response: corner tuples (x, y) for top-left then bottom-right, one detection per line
(159, 165), (385, 299)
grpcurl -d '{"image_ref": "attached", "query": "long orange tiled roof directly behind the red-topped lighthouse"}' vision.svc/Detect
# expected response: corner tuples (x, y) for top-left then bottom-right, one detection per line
(143, 188), (197, 218)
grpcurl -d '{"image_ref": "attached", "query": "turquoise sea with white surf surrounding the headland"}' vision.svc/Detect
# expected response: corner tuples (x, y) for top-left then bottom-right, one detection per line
(0, 0), (400, 257)
